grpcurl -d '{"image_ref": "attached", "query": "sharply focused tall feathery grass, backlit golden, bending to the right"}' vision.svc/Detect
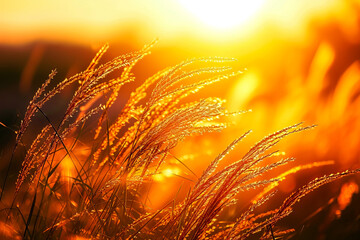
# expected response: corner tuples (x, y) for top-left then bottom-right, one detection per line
(0, 43), (359, 239)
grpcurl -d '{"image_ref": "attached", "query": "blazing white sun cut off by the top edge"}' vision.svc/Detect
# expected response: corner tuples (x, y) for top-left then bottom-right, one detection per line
(179, 0), (265, 29)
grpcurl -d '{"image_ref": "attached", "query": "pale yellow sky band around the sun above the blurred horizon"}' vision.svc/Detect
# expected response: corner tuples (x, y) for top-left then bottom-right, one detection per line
(0, 0), (339, 44)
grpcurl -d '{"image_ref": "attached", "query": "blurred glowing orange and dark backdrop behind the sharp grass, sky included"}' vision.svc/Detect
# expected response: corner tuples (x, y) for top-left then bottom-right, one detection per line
(0, 0), (360, 239)
